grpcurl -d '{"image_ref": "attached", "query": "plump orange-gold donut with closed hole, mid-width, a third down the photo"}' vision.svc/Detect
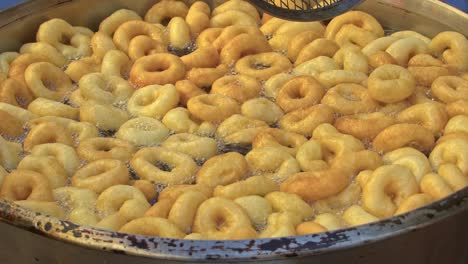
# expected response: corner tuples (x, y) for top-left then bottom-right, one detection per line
(210, 74), (262, 103)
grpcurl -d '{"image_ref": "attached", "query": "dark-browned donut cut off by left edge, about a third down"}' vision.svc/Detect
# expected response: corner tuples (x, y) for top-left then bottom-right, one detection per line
(0, 78), (34, 108)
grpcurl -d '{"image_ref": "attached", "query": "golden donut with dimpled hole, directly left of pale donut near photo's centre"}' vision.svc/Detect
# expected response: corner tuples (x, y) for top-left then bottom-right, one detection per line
(187, 94), (240, 122)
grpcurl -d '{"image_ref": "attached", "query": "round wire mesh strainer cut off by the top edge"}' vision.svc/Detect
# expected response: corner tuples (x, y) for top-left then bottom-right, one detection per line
(248, 0), (363, 21)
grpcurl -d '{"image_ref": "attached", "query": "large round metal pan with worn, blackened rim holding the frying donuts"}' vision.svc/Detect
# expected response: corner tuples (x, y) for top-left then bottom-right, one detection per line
(0, 0), (468, 264)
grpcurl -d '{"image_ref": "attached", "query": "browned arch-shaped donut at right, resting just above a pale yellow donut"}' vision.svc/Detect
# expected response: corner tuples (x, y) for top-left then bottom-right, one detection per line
(372, 123), (435, 152)
